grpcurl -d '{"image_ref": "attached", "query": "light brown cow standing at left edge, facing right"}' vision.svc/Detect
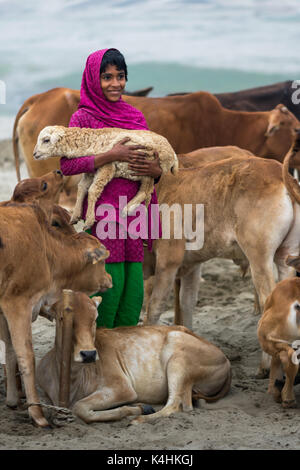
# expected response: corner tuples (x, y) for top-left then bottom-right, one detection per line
(0, 203), (112, 426)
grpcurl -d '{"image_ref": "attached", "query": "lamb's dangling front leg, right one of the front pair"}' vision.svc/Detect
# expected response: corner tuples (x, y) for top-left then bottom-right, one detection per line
(83, 163), (116, 230)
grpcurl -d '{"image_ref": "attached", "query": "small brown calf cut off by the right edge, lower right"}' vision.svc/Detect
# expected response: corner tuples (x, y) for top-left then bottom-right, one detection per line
(257, 257), (300, 408)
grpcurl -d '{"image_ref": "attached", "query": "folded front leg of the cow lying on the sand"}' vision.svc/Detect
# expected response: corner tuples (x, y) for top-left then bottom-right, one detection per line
(72, 384), (142, 423)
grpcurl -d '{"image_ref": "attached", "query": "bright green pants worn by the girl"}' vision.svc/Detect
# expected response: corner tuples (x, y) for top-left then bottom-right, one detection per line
(92, 261), (144, 328)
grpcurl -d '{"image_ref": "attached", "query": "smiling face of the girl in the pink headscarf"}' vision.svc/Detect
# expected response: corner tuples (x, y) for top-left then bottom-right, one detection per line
(100, 65), (126, 102)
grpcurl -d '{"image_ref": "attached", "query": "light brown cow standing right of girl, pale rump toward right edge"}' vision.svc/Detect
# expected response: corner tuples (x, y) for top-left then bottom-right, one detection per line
(145, 141), (300, 336)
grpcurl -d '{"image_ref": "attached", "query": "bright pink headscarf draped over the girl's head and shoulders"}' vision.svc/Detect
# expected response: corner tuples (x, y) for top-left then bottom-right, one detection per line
(78, 49), (148, 130)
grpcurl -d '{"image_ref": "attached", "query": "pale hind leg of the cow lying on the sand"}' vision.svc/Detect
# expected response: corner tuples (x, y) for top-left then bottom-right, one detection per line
(131, 355), (193, 424)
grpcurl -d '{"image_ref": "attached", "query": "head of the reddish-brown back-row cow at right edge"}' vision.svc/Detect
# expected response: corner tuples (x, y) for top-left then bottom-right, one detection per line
(260, 104), (300, 161)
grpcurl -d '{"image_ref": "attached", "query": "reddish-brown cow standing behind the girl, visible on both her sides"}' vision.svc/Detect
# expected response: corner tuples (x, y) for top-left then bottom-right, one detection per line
(13, 88), (300, 198)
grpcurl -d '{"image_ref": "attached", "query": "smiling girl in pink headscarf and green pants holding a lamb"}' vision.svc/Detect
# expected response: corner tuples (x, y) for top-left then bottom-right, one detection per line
(61, 49), (161, 328)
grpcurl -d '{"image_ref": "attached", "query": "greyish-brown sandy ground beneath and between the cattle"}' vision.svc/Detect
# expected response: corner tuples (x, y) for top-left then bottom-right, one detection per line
(0, 141), (300, 450)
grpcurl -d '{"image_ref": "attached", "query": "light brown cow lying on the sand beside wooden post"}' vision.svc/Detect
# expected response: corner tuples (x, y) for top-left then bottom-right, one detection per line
(37, 293), (231, 424)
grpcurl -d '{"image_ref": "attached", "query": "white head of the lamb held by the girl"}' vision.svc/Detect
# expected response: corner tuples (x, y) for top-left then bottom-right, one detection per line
(33, 126), (66, 160)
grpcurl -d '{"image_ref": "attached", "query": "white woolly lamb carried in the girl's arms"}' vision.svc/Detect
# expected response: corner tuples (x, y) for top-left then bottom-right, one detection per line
(33, 126), (178, 229)
